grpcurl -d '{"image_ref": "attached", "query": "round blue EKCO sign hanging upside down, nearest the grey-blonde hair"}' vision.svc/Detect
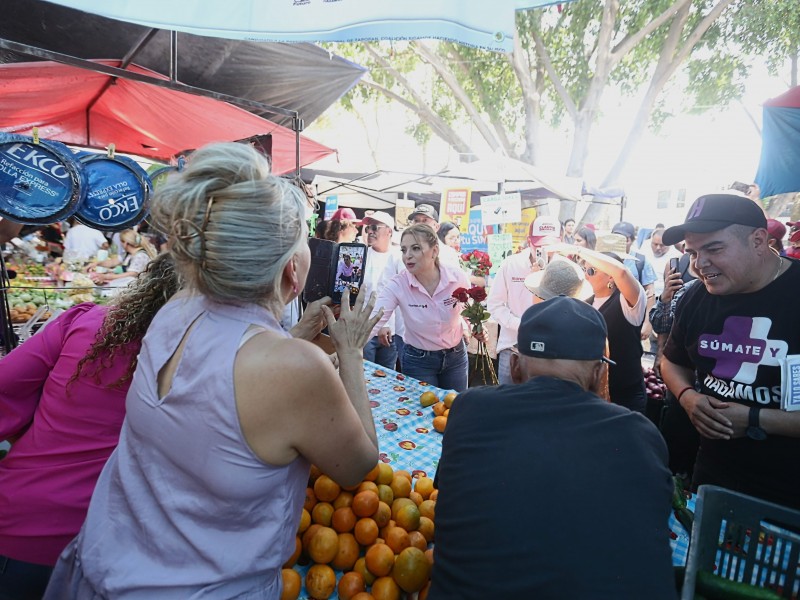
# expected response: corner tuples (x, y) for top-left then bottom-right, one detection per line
(75, 154), (152, 231)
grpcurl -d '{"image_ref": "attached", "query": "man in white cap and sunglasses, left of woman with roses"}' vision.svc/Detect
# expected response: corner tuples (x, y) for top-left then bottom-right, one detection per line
(363, 211), (405, 369)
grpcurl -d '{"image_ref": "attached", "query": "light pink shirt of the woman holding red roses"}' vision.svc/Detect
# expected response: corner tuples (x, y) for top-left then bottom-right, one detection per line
(372, 264), (470, 350)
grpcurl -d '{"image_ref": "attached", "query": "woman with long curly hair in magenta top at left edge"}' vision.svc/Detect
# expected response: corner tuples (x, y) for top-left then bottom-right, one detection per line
(0, 255), (179, 598)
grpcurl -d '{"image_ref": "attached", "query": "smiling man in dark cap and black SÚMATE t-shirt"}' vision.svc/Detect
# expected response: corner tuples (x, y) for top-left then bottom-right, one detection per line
(661, 194), (800, 508)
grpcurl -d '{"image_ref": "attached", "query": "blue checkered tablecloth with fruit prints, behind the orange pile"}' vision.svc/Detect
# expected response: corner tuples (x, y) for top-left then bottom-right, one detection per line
(364, 360), (450, 477)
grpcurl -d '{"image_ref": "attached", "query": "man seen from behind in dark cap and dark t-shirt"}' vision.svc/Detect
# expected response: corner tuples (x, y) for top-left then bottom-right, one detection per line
(428, 296), (675, 600)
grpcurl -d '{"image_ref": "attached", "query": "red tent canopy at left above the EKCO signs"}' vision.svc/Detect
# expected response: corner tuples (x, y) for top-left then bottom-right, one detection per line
(0, 60), (334, 174)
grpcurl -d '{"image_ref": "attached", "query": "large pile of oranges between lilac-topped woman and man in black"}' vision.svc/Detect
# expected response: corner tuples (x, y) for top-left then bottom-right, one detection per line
(281, 462), (438, 600)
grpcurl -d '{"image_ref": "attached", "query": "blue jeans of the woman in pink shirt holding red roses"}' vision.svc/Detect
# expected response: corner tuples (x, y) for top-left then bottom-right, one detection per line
(401, 340), (469, 392)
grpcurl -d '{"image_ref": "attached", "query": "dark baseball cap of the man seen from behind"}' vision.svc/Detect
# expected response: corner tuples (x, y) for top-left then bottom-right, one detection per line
(517, 296), (616, 365)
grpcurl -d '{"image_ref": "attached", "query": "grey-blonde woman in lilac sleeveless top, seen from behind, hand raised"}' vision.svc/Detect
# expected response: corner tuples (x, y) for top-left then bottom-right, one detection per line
(45, 143), (378, 600)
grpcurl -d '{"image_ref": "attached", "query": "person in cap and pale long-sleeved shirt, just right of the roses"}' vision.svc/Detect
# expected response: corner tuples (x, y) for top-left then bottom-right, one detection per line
(486, 216), (561, 384)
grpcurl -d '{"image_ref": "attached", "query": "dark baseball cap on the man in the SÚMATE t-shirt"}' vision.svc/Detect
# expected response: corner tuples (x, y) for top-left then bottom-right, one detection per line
(661, 194), (767, 246)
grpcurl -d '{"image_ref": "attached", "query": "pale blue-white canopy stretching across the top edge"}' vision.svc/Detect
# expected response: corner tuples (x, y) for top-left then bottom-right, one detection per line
(42, 0), (568, 52)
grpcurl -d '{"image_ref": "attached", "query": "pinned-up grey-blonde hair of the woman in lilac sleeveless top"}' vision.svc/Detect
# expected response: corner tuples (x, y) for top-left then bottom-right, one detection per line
(151, 143), (307, 316)
